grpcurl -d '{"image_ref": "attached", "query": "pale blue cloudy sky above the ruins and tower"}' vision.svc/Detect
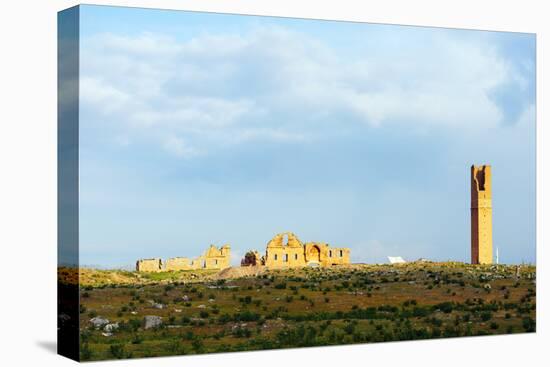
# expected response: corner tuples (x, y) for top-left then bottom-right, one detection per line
(76, 6), (535, 267)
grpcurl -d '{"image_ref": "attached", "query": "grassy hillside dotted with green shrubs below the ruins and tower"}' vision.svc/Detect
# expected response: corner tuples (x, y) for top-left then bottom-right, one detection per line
(80, 263), (536, 360)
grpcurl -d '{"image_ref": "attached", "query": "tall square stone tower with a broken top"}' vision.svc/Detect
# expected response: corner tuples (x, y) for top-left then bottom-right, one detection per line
(470, 165), (493, 264)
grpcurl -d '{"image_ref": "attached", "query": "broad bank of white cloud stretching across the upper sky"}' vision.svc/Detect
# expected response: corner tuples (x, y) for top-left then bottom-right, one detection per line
(81, 28), (523, 157)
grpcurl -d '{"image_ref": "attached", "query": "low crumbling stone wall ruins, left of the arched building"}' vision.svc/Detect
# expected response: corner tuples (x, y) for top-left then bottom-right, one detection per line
(136, 244), (231, 272)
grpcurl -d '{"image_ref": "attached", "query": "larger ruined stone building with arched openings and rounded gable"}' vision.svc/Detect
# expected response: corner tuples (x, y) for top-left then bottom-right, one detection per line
(265, 232), (350, 268)
